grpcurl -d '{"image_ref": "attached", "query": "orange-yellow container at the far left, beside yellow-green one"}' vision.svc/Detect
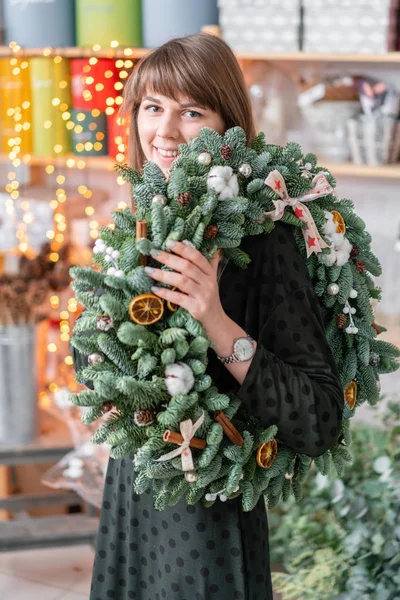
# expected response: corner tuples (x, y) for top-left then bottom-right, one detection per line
(0, 58), (32, 154)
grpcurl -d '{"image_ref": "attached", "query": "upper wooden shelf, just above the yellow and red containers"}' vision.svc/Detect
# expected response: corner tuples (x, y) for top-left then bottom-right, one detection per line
(0, 46), (400, 64)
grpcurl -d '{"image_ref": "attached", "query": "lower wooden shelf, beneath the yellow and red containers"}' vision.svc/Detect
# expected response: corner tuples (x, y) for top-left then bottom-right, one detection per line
(0, 154), (400, 179)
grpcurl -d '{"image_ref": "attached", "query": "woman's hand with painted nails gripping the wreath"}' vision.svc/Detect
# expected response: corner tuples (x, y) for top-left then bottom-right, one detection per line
(145, 240), (225, 326)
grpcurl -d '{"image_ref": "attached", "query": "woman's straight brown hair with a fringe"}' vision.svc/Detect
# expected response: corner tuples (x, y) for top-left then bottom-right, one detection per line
(121, 33), (256, 171)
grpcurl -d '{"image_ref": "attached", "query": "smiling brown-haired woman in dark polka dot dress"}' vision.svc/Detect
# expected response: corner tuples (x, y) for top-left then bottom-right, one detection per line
(75, 34), (343, 600)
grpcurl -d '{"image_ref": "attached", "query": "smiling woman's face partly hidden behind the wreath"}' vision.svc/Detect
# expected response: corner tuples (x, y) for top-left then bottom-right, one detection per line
(137, 92), (224, 174)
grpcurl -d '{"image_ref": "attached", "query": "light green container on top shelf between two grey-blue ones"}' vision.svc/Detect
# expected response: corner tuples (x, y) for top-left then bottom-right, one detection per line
(76, 0), (142, 48)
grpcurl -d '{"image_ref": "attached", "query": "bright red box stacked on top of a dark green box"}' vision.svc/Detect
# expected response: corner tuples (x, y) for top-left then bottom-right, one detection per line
(71, 57), (120, 112)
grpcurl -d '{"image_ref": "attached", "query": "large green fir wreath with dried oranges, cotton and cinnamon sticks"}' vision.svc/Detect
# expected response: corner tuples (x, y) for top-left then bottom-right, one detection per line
(71, 127), (400, 511)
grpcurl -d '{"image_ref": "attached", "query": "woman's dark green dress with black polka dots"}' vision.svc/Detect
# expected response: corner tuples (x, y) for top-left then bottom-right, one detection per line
(75, 223), (343, 600)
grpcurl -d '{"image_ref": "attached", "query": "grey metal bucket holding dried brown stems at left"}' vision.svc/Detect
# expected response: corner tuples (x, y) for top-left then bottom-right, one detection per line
(0, 325), (38, 444)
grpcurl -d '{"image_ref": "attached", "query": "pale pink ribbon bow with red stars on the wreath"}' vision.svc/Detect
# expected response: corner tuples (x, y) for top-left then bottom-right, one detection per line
(264, 170), (334, 258)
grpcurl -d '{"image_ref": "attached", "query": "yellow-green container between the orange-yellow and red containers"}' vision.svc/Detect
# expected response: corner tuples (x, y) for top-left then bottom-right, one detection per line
(29, 57), (72, 156)
